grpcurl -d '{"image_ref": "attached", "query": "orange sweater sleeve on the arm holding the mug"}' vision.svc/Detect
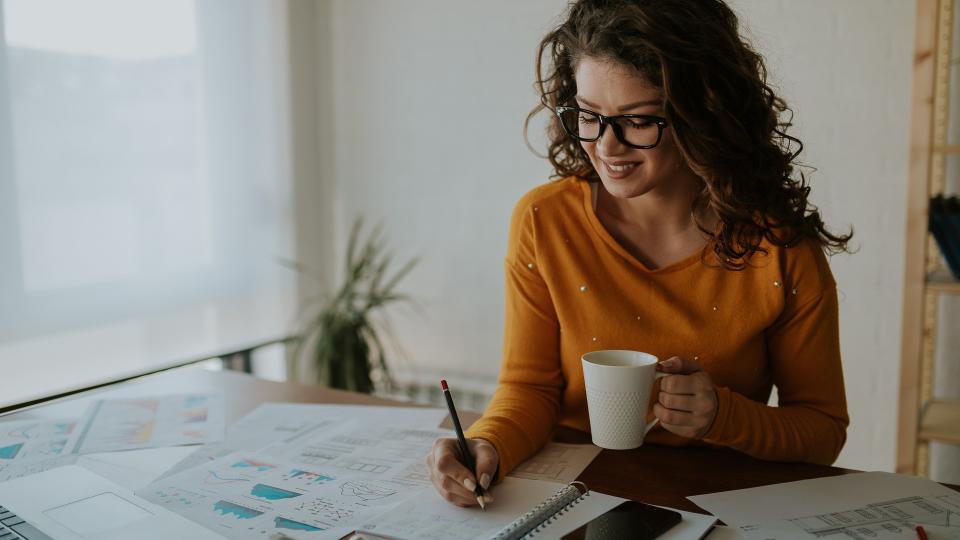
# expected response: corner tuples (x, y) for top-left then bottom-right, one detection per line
(704, 255), (850, 464)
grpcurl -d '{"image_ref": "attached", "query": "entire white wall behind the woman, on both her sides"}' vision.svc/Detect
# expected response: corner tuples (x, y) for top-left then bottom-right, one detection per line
(325, 0), (914, 470)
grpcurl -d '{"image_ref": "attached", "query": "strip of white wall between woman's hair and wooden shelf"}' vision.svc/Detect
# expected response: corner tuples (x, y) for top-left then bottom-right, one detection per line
(734, 0), (914, 470)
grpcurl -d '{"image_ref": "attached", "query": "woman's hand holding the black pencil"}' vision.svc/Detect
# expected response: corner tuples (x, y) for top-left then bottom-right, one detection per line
(427, 438), (500, 506)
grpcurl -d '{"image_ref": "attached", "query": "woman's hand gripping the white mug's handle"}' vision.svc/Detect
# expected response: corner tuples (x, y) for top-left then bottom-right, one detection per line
(653, 356), (717, 439)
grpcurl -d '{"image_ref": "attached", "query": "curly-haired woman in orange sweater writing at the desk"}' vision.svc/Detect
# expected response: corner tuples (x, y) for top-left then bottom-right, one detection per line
(427, 0), (851, 506)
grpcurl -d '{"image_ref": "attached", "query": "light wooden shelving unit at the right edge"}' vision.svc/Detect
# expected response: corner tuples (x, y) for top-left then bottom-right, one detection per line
(897, 0), (960, 476)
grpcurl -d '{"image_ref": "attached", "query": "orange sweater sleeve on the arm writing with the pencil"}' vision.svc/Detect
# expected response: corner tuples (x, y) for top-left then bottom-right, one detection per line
(466, 200), (564, 481)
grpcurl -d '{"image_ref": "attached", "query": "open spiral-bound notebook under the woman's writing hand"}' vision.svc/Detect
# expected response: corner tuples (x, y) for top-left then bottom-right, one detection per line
(361, 477), (626, 540)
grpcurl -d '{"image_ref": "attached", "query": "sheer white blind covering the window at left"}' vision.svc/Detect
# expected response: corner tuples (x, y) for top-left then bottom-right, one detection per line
(0, 0), (294, 405)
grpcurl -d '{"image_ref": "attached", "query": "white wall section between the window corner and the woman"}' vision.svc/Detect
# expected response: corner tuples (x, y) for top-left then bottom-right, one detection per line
(333, 0), (563, 396)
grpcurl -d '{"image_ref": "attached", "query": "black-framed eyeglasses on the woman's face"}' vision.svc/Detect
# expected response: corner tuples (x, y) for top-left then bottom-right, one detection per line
(556, 107), (667, 150)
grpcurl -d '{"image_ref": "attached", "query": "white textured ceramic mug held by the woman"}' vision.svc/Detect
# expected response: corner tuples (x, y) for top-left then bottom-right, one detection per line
(580, 350), (667, 450)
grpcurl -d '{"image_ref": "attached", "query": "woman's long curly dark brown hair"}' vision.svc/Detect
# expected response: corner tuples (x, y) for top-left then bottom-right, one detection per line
(525, 0), (853, 269)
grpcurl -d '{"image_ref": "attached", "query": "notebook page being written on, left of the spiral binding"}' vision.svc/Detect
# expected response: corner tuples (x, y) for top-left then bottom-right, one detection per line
(361, 477), (565, 540)
